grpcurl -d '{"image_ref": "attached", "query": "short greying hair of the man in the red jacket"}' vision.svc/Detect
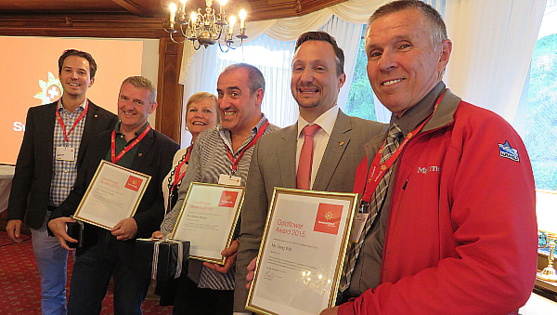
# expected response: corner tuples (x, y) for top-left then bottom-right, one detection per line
(368, 0), (448, 46)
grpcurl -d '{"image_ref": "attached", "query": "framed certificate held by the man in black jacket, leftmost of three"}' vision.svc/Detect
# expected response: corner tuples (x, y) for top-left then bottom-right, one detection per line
(73, 160), (151, 230)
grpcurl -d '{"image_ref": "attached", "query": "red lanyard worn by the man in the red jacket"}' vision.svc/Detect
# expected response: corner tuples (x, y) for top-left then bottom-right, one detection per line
(355, 93), (445, 203)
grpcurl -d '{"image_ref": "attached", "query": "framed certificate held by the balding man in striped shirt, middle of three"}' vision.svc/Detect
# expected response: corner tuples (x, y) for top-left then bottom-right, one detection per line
(171, 182), (244, 265)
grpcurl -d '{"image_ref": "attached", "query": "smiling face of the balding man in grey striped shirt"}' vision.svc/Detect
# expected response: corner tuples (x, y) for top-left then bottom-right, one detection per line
(217, 68), (264, 134)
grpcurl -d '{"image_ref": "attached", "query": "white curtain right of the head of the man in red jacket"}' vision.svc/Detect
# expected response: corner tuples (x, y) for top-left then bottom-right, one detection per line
(445, 0), (547, 122)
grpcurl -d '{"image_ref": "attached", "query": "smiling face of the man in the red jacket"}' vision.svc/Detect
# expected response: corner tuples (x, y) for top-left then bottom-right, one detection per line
(366, 9), (452, 117)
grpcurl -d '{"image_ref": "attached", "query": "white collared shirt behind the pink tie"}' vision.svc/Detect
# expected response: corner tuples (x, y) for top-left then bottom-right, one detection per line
(296, 105), (339, 187)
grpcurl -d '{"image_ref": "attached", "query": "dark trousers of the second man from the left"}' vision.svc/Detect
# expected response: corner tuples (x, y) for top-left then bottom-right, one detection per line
(68, 230), (150, 315)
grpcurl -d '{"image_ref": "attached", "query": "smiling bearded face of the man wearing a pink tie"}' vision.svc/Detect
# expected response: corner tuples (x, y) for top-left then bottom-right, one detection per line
(290, 40), (346, 121)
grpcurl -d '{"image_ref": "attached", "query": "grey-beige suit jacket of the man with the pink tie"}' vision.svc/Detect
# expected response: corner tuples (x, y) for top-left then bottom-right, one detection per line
(234, 111), (387, 312)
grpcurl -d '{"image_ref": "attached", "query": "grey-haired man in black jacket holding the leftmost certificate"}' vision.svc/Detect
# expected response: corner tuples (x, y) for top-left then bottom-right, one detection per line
(48, 76), (178, 315)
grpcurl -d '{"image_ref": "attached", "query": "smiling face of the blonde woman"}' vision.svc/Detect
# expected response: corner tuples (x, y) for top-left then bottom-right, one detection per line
(186, 98), (218, 139)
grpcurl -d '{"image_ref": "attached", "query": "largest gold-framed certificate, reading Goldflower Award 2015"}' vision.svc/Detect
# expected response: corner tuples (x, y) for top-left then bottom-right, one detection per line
(246, 188), (359, 315)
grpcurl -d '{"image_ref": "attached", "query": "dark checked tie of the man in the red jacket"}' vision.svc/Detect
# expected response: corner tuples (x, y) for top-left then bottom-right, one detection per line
(340, 124), (404, 292)
